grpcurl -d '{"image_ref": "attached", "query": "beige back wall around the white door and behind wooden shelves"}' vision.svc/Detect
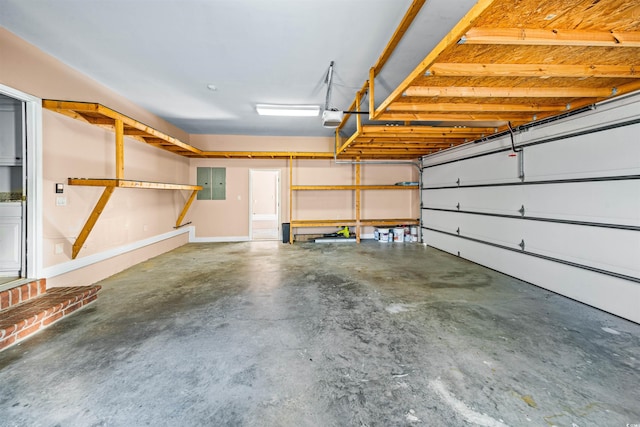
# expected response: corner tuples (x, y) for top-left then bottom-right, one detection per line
(190, 135), (419, 238)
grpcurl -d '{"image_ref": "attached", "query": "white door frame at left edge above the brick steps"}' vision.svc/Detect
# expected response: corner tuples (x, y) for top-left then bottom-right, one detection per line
(0, 84), (43, 279)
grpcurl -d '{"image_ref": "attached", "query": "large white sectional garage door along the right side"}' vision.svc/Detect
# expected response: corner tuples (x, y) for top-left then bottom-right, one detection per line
(422, 96), (640, 322)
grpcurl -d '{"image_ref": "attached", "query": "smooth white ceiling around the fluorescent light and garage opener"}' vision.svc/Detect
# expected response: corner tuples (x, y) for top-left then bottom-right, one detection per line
(0, 0), (471, 136)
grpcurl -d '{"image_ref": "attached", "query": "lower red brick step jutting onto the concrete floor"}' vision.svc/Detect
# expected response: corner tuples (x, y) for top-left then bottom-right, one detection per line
(0, 285), (102, 350)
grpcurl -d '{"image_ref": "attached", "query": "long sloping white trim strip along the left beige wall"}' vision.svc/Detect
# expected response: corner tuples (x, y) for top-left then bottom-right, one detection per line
(42, 226), (194, 279)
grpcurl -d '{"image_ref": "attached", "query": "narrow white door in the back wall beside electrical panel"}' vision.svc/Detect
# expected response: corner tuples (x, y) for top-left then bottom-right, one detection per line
(249, 169), (280, 240)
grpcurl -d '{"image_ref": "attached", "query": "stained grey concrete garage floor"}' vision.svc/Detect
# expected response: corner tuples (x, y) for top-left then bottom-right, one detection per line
(0, 242), (640, 427)
